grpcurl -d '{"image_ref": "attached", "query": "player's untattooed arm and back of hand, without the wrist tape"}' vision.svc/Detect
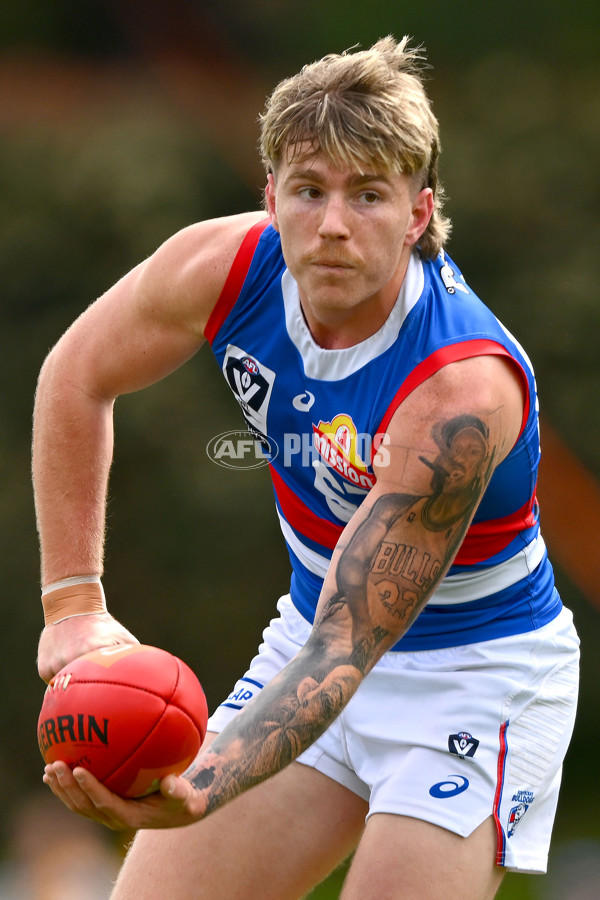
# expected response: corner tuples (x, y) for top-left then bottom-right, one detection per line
(33, 213), (263, 678)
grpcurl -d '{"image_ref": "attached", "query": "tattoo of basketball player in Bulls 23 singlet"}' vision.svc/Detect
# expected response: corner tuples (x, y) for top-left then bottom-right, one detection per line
(320, 415), (494, 640)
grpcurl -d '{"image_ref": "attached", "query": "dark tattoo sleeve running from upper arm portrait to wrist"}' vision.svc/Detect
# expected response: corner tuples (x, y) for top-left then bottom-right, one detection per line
(186, 415), (494, 811)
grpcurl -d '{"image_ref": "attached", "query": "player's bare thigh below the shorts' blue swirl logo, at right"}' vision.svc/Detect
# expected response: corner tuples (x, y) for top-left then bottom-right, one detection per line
(341, 813), (504, 900)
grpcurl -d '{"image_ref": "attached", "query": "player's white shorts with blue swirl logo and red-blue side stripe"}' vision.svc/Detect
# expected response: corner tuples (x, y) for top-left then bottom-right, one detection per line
(208, 596), (579, 872)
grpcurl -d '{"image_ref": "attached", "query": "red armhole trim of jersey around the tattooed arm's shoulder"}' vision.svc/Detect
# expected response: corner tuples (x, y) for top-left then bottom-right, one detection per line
(373, 338), (529, 456)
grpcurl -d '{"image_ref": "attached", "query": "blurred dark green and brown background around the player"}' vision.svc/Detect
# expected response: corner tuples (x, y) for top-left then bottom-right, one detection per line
(0, 0), (600, 900)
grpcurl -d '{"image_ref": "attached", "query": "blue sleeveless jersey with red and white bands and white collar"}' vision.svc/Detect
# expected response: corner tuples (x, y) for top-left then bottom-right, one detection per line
(205, 222), (562, 651)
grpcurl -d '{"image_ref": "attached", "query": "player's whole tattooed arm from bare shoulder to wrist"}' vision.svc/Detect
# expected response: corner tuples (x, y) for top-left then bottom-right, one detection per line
(187, 359), (522, 811)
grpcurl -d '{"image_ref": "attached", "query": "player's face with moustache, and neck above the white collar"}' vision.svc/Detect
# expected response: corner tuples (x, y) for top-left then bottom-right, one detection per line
(267, 152), (433, 343)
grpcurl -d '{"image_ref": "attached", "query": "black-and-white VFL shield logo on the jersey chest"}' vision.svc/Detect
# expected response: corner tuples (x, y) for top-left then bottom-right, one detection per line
(223, 344), (275, 435)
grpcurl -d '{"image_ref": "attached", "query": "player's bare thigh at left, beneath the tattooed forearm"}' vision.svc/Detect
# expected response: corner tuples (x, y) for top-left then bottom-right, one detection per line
(112, 763), (367, 900)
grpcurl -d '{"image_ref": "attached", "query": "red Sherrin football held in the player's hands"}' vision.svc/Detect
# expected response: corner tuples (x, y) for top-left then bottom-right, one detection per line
(38, 644), (208, 797)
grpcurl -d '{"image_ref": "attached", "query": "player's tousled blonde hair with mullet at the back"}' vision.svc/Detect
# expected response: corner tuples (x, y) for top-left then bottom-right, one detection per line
(260, 36), (451, 259)
